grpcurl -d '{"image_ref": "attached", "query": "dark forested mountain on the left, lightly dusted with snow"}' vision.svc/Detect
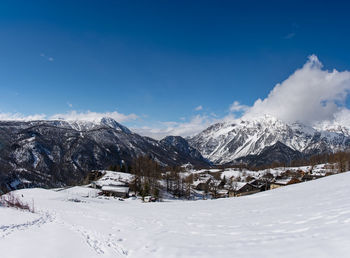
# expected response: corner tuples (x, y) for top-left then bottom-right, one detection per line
(0, 118), (208, 192)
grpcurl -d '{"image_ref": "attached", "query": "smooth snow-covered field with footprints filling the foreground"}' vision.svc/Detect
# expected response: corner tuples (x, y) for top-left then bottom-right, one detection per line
(0, 172), (350, 258)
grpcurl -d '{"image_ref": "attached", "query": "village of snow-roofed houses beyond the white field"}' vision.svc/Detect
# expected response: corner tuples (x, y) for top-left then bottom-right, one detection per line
(88, 164), (338, 202)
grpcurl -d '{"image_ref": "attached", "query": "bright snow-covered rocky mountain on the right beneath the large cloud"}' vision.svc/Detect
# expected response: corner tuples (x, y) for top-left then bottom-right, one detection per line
(188, 115), (350, 164)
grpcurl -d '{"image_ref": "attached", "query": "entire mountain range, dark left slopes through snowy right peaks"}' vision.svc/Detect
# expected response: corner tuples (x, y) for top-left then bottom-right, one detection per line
(0, 115), (350, 191)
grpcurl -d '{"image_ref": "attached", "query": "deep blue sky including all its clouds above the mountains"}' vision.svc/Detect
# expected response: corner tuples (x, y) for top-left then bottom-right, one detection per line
(0, 0), (350, 138)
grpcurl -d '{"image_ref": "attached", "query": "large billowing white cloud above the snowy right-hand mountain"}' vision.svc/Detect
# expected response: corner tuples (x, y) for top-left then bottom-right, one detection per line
(244, 55), (350, 124)
